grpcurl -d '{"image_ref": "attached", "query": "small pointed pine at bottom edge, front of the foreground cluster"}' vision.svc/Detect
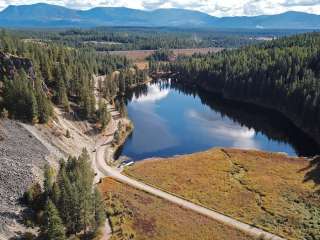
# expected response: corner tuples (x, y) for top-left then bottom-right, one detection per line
(45, 200), (66, 240)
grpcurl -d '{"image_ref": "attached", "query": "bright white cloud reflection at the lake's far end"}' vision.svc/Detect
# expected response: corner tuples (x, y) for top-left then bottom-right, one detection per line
(132, 84), (170, 103)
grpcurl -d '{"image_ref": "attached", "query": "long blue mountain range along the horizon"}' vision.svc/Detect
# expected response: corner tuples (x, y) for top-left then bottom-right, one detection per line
(0, 3), (320, 29)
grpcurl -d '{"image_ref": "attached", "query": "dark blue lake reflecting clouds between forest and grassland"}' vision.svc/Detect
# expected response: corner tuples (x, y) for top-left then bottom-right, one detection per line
(119, 80), (320, 161)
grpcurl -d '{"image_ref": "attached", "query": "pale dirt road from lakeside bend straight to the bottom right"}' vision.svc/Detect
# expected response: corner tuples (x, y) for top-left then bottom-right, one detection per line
(94, 139), (284, 240)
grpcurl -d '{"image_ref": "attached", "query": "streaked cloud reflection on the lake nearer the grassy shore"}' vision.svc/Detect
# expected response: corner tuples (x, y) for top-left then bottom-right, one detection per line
(186, 109), (259, 149)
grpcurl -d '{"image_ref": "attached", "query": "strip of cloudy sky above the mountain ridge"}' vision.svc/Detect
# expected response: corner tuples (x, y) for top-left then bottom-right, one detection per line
(0, 0), (320, 16)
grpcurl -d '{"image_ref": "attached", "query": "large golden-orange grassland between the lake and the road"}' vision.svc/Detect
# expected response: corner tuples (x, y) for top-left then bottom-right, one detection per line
(125, 149), (320, 239)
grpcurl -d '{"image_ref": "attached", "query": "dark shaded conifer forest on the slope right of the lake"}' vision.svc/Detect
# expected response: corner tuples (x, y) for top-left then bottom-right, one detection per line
(170, 33), (320, 142)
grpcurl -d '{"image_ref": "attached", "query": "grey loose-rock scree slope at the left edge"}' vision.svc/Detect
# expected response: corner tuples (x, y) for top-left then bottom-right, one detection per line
(0, 120), (49, 239)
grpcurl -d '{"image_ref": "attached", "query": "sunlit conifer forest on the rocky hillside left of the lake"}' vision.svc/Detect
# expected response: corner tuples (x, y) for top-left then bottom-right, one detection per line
(0, 31), (146, 123)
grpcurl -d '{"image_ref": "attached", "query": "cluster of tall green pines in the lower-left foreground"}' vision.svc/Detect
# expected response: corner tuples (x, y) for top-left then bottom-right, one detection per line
(25, 149), (106, 240)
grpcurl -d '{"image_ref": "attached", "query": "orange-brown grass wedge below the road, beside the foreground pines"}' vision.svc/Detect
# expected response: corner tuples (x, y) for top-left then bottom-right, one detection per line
(99, 178), (253, 240)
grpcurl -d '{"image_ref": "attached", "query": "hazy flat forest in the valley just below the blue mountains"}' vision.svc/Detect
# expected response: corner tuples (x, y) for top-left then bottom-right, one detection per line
(13, 27), (304, 51)
